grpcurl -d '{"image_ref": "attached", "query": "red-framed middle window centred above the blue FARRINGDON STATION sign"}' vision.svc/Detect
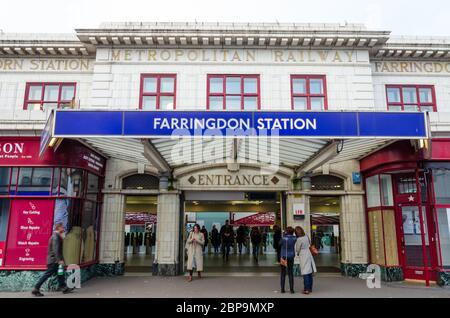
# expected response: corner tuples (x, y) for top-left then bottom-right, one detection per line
(207, 75), (261, 111)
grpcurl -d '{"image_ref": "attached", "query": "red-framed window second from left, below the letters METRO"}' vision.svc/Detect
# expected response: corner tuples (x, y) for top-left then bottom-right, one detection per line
(140, 74), (177, 110)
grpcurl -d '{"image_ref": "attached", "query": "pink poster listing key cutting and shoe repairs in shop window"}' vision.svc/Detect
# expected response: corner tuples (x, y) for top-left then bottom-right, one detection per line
(5, 199), (54, 267)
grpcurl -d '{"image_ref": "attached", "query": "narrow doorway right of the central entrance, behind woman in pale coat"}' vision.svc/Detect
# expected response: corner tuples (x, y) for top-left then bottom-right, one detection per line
(310, 196), (342, 272)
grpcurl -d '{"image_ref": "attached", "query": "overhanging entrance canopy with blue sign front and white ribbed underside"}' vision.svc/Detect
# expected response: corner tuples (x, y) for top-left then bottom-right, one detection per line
(42, 110), (429, 172)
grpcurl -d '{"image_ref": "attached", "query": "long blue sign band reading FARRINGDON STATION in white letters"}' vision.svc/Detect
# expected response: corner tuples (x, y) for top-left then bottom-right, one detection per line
(52, 110), (428, 139)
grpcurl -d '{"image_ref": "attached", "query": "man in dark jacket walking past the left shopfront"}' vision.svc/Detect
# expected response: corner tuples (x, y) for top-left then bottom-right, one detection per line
(31, 223), (73, 297)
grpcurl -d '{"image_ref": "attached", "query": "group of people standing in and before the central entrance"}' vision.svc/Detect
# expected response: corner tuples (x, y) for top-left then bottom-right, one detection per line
(186, 220), (318, 295)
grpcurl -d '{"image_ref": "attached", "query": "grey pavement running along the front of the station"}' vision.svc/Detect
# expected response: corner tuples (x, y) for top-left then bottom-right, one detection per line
(0, 274), (450, 298)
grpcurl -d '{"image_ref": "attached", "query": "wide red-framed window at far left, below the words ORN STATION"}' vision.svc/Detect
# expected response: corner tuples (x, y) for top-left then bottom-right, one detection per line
(23, 83), (76, 110)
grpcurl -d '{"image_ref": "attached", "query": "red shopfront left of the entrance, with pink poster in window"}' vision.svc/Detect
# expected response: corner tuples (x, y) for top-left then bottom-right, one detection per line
(0, 137), (106, 271)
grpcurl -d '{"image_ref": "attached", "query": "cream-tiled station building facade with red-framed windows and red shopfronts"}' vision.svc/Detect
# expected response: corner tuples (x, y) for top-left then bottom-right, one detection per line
(0, 23), (450, 290)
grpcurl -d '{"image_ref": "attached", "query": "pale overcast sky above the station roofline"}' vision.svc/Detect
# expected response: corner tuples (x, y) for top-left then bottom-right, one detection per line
(0, 0), (450, 36)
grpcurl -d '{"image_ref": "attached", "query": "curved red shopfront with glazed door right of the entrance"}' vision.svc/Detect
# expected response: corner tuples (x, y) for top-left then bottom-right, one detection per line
(361, 139), (450, 285)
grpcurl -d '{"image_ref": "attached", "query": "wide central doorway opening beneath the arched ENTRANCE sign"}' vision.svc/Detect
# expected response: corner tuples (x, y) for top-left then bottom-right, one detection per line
(183, 193), (282, 274)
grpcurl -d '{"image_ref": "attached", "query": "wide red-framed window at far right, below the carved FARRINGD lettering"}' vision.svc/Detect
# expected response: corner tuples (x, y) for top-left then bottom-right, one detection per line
(386, 85), (437, 112)
